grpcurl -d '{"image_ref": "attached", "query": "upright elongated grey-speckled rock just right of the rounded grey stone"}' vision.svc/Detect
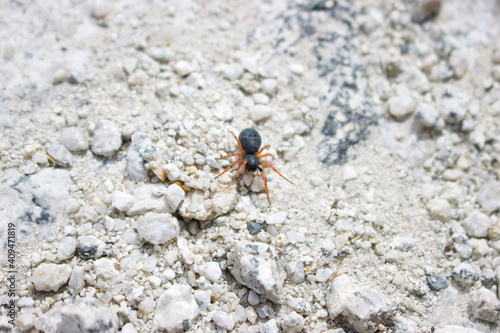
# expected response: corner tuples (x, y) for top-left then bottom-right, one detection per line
(127, 132), (154, 182)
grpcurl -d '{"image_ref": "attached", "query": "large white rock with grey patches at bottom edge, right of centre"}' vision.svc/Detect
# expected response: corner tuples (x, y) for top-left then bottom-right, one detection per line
(326, 274), (395, 333)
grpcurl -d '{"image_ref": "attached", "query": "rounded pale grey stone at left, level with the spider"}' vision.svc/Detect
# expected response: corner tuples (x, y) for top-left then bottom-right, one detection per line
(91, 119), (122, 156)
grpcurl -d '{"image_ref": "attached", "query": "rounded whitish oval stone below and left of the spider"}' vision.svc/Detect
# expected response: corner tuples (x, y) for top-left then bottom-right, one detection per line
(137, 212), (180, 245)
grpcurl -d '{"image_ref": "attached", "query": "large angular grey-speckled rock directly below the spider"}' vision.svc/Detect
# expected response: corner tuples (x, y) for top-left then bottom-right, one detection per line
(227, 241), (285, 303)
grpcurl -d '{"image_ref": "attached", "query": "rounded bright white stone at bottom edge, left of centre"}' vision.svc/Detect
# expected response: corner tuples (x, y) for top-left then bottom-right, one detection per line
(154, 284), (200, 333)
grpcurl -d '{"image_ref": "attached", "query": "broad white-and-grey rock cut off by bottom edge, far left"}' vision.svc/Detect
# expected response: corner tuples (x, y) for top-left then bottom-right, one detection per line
(57, 298), (118, 333)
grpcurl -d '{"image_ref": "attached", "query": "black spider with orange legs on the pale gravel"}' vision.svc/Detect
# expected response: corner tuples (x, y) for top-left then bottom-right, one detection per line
(215, 128), (293, 204)
